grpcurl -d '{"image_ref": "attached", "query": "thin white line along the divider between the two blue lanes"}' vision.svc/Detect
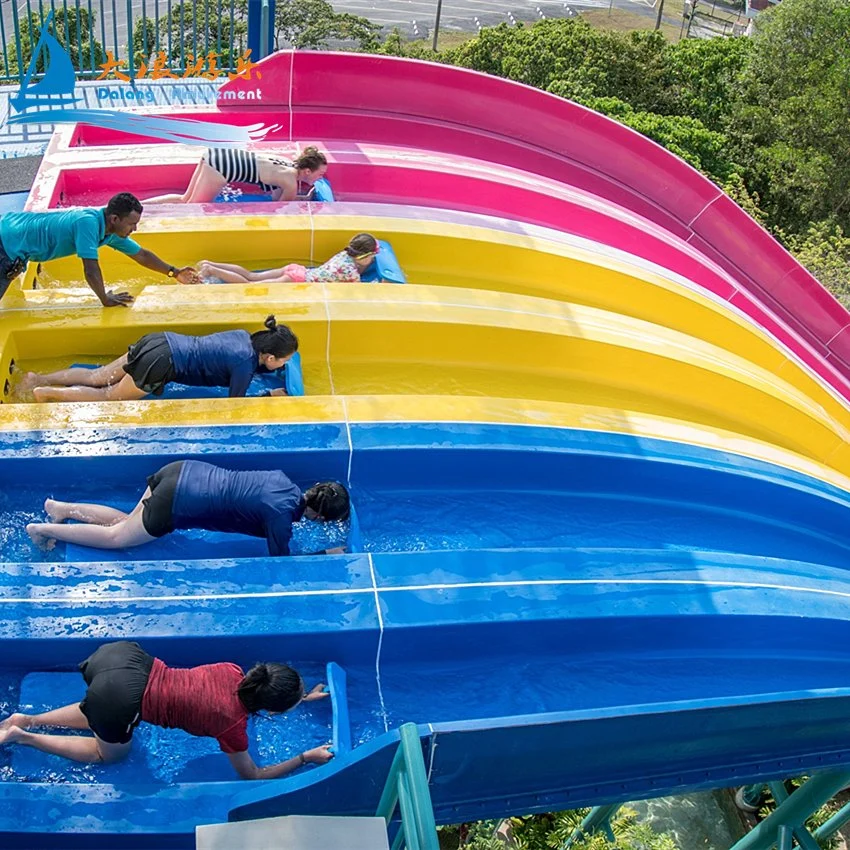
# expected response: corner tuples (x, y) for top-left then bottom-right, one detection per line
(0, 576), (850, 604)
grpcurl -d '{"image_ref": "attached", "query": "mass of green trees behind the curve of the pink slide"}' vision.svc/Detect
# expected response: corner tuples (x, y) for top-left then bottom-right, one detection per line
(382, 0), (850, 297)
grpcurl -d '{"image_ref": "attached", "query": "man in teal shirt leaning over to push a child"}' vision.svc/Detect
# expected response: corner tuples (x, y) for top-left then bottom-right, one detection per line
(0, 192), (197, 307)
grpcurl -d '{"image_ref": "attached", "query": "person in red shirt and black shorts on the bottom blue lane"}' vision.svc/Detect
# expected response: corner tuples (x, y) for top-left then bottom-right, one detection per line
(0, 641), (333, 779)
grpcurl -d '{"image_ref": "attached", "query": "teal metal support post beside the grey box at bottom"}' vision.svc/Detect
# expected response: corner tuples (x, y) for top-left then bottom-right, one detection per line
(376, 723), (439, 850)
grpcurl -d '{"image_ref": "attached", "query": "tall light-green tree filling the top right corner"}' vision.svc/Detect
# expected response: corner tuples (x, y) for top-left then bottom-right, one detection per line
(732, 0), (850, 233)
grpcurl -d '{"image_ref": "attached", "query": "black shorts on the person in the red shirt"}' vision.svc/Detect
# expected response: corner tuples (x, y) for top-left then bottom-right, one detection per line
(80, 640), (153, 744)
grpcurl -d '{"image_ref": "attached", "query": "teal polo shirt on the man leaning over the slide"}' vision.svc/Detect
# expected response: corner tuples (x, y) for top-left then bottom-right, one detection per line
(0, 207), (142, 263)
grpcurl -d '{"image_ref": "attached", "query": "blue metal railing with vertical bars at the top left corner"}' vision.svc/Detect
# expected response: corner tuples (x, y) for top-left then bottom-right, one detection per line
(0, 0), (252, 83)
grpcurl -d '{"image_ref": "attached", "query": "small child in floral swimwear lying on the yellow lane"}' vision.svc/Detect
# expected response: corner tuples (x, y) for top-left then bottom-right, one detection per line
(198, 233), (381, 283)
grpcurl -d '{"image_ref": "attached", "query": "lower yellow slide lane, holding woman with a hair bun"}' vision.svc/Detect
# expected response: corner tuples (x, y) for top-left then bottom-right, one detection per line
(0, 284), (850, 475)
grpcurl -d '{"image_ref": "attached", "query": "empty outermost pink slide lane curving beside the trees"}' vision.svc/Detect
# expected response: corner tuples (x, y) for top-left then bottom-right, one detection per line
(51, 51), (850, 398)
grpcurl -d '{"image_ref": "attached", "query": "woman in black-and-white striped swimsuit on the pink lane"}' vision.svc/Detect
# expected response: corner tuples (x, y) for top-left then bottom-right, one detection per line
(144, 146), (328, 204)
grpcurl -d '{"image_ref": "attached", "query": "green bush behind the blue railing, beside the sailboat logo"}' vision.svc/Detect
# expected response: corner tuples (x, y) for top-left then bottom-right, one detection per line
(6, 6), (106, 75)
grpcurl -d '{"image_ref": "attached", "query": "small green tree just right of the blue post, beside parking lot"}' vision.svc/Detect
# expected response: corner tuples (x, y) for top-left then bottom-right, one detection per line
(274, 0), (381, 50)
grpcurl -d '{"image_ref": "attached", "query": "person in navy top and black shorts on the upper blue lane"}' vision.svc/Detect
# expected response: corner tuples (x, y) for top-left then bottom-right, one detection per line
(27, 460), (350, 555)
